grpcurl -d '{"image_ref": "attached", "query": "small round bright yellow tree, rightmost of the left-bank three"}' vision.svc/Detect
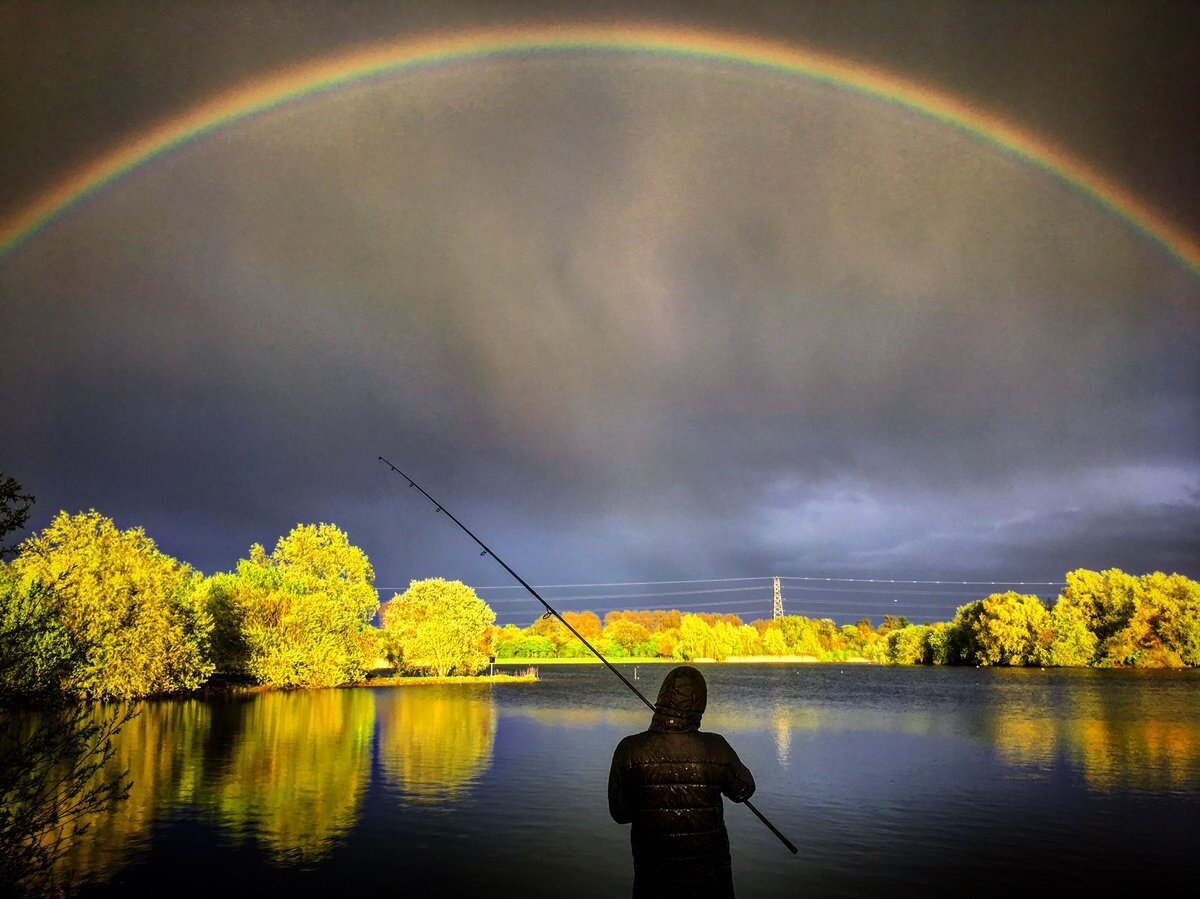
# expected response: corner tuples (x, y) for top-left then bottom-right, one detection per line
(383, 577), (496, 677)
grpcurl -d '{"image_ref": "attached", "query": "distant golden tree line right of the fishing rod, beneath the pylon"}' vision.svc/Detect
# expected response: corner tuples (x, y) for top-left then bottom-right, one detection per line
(492, 569), (1200, 667)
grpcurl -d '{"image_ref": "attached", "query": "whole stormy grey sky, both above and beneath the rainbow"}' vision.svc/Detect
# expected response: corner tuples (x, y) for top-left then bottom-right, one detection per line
(0, 1), (1200, 623)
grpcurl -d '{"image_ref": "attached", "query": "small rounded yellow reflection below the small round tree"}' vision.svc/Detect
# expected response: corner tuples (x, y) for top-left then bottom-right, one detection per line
(377, 687), (496, 804)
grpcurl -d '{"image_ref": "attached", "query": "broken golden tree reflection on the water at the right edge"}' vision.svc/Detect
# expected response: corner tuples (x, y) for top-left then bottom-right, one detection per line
(989, 671), (1200, 790)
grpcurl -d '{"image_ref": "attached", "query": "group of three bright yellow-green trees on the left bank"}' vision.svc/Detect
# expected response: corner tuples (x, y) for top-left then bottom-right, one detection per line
(0, 510), (508, 700)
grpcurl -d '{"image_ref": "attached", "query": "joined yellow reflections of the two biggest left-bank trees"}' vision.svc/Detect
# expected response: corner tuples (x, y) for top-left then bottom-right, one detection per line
(36, 690), (374, 882)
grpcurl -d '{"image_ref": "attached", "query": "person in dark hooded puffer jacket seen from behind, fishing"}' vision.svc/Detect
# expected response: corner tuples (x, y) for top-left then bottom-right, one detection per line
(608, 665), (754, 899)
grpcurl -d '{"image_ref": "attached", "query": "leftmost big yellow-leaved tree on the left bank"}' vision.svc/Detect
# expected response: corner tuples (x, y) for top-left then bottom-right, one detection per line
(13, 510), (212, 699)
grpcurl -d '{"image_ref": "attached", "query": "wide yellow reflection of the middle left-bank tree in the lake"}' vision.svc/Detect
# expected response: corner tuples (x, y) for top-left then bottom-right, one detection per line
(200, 690), (374, 861)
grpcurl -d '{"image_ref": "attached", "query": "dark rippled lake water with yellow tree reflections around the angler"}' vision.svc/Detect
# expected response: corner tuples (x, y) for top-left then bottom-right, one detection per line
(63, 666), (1200, 898)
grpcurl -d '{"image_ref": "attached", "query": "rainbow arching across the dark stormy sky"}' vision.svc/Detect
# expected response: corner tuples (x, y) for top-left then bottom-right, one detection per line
(0, 25), (1200, 277)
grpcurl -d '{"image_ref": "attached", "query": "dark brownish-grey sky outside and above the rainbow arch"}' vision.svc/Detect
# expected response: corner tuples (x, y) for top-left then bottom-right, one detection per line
(0, 0), (1200, 232)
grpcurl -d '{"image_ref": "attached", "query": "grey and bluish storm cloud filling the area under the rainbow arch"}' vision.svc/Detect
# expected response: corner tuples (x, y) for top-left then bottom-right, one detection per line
(0, 50), (1200, 595)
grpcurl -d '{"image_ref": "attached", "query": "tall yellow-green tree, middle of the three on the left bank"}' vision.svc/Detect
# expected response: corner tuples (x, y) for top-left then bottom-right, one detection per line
(206, 525), (379, 687)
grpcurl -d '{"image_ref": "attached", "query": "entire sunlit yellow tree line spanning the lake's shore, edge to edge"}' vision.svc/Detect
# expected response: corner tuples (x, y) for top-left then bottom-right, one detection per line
(0, 484), (1200, 699)
